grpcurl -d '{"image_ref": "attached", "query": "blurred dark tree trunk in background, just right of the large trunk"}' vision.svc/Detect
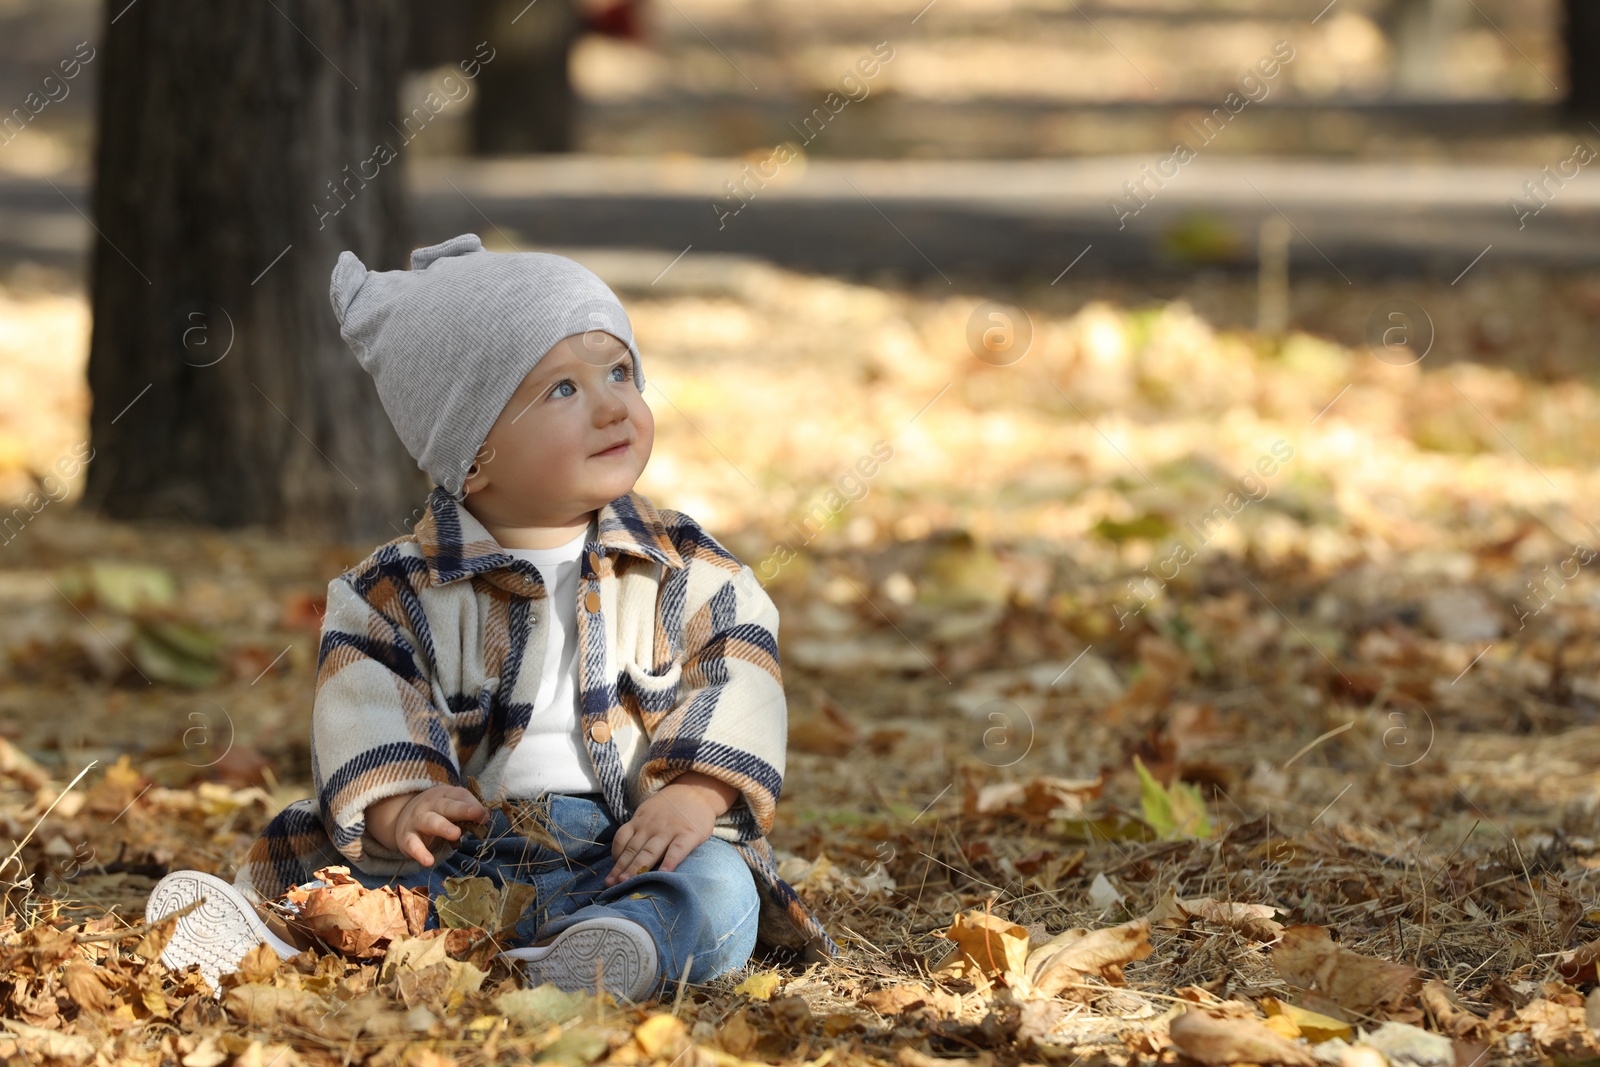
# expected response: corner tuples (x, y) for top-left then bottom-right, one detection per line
(472, 0), (582, 155)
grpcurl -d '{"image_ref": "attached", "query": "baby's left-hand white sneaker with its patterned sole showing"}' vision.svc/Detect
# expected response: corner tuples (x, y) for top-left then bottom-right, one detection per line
(144, 870), (299, 995)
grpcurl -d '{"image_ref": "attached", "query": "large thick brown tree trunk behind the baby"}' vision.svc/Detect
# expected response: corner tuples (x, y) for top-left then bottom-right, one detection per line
(85, 0), (427, 539)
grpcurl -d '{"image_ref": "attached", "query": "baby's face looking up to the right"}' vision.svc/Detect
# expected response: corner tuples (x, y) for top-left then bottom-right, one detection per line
(466, 330), (656, 531)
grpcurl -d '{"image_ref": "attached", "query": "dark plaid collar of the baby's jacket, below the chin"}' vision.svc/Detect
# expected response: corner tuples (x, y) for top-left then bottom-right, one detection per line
(414, 486), (686, 585)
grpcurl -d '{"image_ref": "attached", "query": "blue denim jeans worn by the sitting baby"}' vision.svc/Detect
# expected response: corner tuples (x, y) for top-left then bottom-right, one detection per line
(339, 793), (760, 984)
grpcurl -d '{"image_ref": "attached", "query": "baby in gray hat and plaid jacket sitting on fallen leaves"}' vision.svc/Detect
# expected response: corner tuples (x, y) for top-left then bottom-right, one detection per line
(146, 234), (838, 1001)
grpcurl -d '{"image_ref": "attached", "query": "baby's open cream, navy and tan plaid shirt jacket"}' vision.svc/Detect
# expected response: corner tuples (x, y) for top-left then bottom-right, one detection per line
(237, 488), (838, 958)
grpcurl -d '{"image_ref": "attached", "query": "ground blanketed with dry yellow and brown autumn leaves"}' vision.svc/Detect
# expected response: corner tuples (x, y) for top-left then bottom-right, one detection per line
(0, 260), (1600, 1067)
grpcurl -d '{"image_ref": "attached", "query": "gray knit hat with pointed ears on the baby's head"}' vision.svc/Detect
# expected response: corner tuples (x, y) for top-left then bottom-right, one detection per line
(328, 234), (645, 501)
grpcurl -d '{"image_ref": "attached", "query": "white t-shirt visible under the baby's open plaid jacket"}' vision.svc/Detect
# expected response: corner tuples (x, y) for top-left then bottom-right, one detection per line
(504, 530), (602, 797)
